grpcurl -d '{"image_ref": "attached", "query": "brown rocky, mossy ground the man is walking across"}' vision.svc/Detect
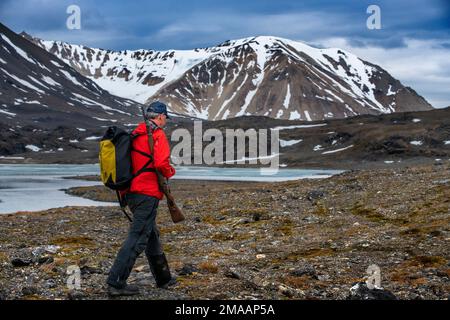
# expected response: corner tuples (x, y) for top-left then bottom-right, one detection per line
(0, 161), (450, 299)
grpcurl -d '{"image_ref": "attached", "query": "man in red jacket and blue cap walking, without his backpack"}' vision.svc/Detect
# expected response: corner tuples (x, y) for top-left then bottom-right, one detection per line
(107, 101), (176, 296)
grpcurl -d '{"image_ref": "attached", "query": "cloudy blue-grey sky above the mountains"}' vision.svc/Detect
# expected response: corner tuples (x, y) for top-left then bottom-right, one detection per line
(0, 0), (450, 108)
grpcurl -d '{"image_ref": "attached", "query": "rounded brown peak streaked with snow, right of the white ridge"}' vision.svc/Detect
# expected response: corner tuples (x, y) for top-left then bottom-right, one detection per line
(153, 37), (432, 121)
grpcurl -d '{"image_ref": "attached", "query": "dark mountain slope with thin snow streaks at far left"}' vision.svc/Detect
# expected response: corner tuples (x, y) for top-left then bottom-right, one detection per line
(0, 24), (139, 127)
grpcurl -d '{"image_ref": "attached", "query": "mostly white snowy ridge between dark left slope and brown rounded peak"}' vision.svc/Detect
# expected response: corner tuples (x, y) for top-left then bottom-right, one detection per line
(22, 33), (221, 103)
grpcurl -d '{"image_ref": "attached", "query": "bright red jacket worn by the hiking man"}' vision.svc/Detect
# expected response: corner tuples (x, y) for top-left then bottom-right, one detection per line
(129, 122), (175, 200)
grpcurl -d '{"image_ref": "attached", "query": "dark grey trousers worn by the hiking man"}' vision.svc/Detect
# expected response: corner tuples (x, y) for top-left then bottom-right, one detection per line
(106, 193), (163, 288)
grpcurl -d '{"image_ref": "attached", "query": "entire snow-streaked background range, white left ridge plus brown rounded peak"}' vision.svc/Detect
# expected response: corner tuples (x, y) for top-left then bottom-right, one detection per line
(24, 34), (433, 121)
